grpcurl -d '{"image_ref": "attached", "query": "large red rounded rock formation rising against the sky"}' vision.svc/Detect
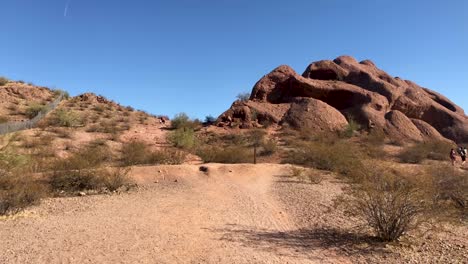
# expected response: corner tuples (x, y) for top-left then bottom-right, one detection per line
(217, 56), (468, 142)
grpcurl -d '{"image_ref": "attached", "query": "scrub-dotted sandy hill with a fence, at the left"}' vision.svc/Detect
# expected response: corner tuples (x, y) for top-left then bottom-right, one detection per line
(0, 81), (168, 161)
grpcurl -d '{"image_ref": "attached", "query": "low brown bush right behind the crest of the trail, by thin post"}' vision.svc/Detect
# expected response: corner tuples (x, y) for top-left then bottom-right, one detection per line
(196, 146), (253, 163)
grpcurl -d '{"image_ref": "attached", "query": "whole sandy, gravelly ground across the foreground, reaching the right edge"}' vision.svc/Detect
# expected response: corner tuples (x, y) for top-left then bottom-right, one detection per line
(0, 164), (468, 263)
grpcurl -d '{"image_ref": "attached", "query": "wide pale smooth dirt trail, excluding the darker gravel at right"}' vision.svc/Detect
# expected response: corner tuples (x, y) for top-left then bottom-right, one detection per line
(0, 164), (348, 263)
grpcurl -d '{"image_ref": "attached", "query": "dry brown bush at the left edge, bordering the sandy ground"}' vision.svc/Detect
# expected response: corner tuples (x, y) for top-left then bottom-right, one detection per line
(0, 172), (47, 215)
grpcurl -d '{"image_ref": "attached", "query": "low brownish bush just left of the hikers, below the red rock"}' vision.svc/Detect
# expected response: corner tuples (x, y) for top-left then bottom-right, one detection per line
(399, 141), (453, 164)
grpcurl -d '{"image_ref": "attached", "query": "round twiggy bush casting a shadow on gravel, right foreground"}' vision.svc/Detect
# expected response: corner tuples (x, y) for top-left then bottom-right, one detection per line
(350, 168), (427, 242)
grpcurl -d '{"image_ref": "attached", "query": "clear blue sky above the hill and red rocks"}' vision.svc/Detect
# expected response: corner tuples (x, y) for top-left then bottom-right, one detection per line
(0, 0), (468, 118)
